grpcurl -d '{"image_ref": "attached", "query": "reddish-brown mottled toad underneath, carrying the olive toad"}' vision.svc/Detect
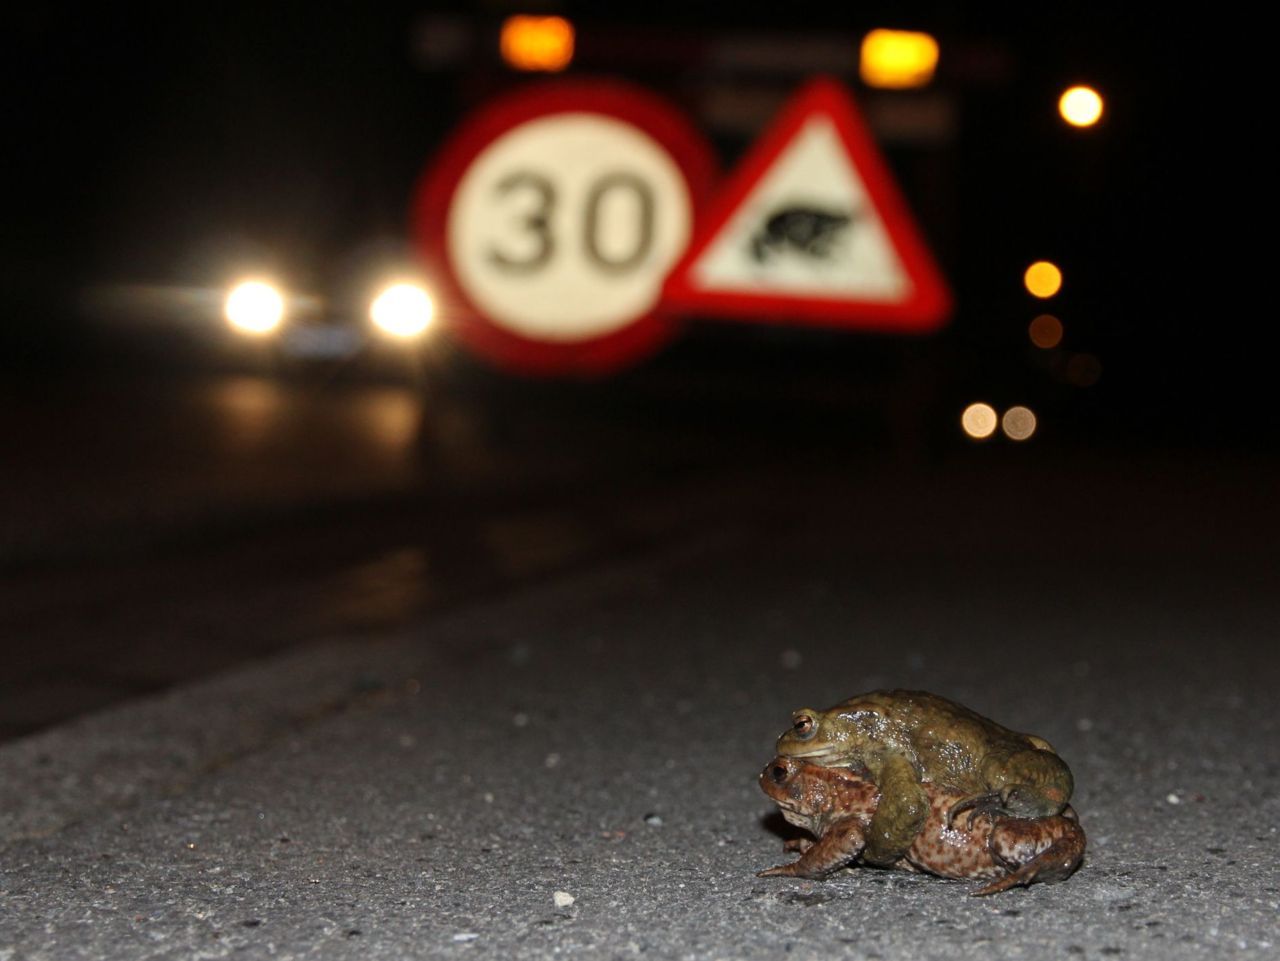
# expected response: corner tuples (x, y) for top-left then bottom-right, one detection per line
(759, 758), (1084, 896)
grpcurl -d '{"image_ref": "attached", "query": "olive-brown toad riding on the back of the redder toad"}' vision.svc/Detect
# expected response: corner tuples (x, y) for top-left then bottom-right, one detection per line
(777, 691), (1073, 865)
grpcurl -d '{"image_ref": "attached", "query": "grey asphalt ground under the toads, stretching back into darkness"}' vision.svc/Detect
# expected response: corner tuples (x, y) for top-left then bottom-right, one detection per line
(0, 368), (1280, 958)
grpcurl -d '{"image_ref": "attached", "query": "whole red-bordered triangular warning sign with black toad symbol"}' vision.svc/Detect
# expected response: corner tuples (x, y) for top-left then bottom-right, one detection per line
(666, 78), (951, 333)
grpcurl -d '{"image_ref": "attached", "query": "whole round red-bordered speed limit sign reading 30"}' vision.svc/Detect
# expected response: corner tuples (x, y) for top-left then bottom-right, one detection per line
(415, 82), (714, 374)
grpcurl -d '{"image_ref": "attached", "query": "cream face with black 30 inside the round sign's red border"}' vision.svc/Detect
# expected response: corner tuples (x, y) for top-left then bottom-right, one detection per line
(445, 111), (692, 343)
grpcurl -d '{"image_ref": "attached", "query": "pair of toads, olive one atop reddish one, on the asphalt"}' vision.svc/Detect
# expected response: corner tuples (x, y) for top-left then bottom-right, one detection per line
(760, 691), (1084, 894)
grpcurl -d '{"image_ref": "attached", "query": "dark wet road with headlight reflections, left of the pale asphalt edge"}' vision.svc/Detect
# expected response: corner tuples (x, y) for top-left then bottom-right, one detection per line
(0, 375), (783, 738)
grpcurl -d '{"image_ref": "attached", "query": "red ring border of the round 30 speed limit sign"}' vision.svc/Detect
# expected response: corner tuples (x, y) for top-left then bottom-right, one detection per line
(412, 79), (717, 376)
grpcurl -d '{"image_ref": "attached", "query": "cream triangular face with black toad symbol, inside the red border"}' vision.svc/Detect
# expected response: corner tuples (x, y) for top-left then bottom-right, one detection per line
(691, 115), (913, 303)
